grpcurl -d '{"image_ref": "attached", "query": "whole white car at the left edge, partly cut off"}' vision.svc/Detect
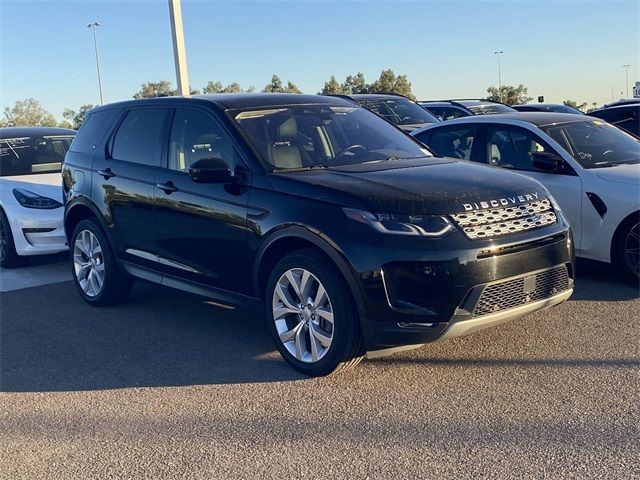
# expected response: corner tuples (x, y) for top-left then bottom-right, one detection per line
(0, 127), (76, 268)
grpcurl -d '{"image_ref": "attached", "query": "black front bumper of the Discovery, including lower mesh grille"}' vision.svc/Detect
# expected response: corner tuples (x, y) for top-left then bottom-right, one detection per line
(336, 223), (575, 357)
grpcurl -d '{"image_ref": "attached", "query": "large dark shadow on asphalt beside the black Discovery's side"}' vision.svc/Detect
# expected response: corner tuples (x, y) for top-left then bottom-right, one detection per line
(0, 282), (306, 392)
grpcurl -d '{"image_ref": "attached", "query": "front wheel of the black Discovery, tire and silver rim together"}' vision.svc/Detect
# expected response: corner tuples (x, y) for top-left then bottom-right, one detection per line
(266, 250), (364, 376)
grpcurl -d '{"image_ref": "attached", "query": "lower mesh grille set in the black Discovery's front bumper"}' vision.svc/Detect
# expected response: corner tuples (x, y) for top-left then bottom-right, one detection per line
(473, 265), (569, 316)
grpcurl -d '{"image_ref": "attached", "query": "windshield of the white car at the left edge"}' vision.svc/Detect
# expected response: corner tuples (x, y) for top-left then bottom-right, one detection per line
(0, 135), (73, 177)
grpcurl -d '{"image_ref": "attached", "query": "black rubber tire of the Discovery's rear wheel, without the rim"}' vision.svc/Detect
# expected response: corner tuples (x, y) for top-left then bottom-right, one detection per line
(69, 218), (133, 306)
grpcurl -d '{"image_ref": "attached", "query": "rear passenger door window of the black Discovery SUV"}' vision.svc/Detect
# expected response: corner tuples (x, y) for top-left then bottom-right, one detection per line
(111, 108), (168, 167)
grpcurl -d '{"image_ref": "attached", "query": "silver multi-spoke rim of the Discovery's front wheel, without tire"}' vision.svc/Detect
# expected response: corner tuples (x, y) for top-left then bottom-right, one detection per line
(273, 268), (334, 363)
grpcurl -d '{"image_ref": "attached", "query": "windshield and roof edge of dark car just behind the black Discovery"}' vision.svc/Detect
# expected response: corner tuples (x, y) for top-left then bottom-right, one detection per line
(335, 93), (440, 132)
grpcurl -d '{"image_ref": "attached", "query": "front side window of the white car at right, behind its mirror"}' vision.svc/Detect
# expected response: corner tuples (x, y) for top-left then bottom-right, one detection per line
(487, 127), (550, 171)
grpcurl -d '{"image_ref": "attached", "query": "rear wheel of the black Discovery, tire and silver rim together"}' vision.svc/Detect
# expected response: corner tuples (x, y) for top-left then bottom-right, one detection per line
(71, 219), (132, 305)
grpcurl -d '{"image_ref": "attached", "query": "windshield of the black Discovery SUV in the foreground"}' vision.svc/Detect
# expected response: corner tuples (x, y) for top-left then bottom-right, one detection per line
(229, 105), (431, 169)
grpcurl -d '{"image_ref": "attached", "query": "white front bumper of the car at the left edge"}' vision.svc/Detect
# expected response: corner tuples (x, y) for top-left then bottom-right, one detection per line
(4, 205), (68, 256)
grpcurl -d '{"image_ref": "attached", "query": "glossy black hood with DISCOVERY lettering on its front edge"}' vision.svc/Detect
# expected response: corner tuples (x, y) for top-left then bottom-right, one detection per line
(272, 158), (548, 214)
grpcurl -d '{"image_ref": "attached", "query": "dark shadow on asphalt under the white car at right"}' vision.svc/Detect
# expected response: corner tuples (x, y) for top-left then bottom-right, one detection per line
(569, 258), (640, 301)
